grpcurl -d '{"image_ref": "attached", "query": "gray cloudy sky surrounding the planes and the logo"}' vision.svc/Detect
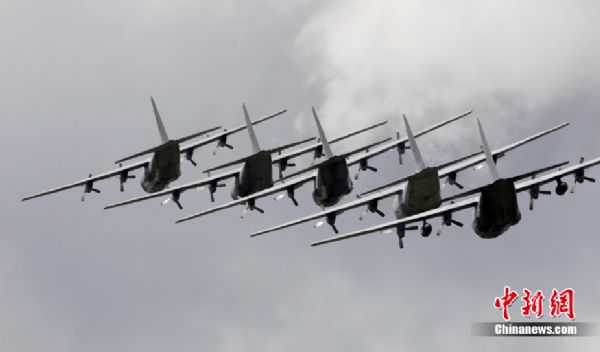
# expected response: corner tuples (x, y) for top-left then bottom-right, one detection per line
(0, 0), (600, 351)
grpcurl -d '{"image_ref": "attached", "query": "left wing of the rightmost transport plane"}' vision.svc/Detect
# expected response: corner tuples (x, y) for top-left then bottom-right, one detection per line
(311, 197), (479, 246)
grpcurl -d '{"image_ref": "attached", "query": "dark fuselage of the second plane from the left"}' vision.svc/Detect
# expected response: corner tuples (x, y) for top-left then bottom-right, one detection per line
(231, 150), (273, 199)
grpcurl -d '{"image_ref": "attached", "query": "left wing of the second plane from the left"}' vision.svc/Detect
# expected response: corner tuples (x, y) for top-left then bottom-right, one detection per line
(104, 170), (239, 209)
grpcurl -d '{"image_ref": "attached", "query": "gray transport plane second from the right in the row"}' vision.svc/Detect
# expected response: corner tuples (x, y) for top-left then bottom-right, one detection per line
(251, 116), (568, 246)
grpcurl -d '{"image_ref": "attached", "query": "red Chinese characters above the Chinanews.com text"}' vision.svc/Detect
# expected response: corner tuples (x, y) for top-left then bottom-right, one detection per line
(494, 286), (575, 321)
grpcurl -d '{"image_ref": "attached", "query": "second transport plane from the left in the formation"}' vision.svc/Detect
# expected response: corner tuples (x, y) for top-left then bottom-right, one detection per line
(105, 106), (387, 210)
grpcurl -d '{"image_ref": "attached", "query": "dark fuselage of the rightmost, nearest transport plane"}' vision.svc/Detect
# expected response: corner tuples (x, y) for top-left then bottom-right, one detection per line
(473, 179), (521, 238)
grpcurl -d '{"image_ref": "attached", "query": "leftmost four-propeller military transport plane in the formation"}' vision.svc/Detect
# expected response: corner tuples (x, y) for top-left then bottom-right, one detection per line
(22, 97), (288, 201)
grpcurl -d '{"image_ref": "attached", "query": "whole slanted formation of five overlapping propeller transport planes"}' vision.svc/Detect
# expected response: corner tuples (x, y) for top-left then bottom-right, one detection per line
(22, 97), (600, 248)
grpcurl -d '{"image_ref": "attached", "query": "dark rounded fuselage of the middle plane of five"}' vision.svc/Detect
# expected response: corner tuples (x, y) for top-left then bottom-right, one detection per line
(312, 156), (353, 207)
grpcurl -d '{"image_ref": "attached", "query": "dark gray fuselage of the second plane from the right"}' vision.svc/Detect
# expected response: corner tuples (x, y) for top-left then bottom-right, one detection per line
(394, 167), (441, 219)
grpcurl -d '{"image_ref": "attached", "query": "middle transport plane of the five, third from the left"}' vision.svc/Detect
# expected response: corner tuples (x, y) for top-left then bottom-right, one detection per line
(176, 108), (472, 223)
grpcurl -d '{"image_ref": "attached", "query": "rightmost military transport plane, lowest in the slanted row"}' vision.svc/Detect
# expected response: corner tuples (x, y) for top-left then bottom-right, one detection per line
(312, 121), (600, 247)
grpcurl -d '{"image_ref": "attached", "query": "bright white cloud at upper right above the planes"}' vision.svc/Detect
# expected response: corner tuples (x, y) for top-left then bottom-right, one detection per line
(297, 0), (600, 154)
